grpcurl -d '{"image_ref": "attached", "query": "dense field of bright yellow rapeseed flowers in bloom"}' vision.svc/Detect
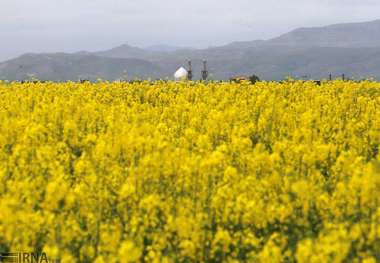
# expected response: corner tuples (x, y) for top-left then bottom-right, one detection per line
(0, 81), (380, 263)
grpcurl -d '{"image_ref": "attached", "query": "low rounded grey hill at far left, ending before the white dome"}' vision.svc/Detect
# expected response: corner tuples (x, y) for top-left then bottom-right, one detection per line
(0, 53), (162, 81)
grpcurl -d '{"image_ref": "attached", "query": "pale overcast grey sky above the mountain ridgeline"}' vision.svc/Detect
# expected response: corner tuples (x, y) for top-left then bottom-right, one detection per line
(0, 0), (380, 60)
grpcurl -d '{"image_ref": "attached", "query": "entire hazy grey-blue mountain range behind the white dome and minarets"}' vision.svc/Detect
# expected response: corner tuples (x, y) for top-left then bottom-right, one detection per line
(0, 20), (380, 81)
